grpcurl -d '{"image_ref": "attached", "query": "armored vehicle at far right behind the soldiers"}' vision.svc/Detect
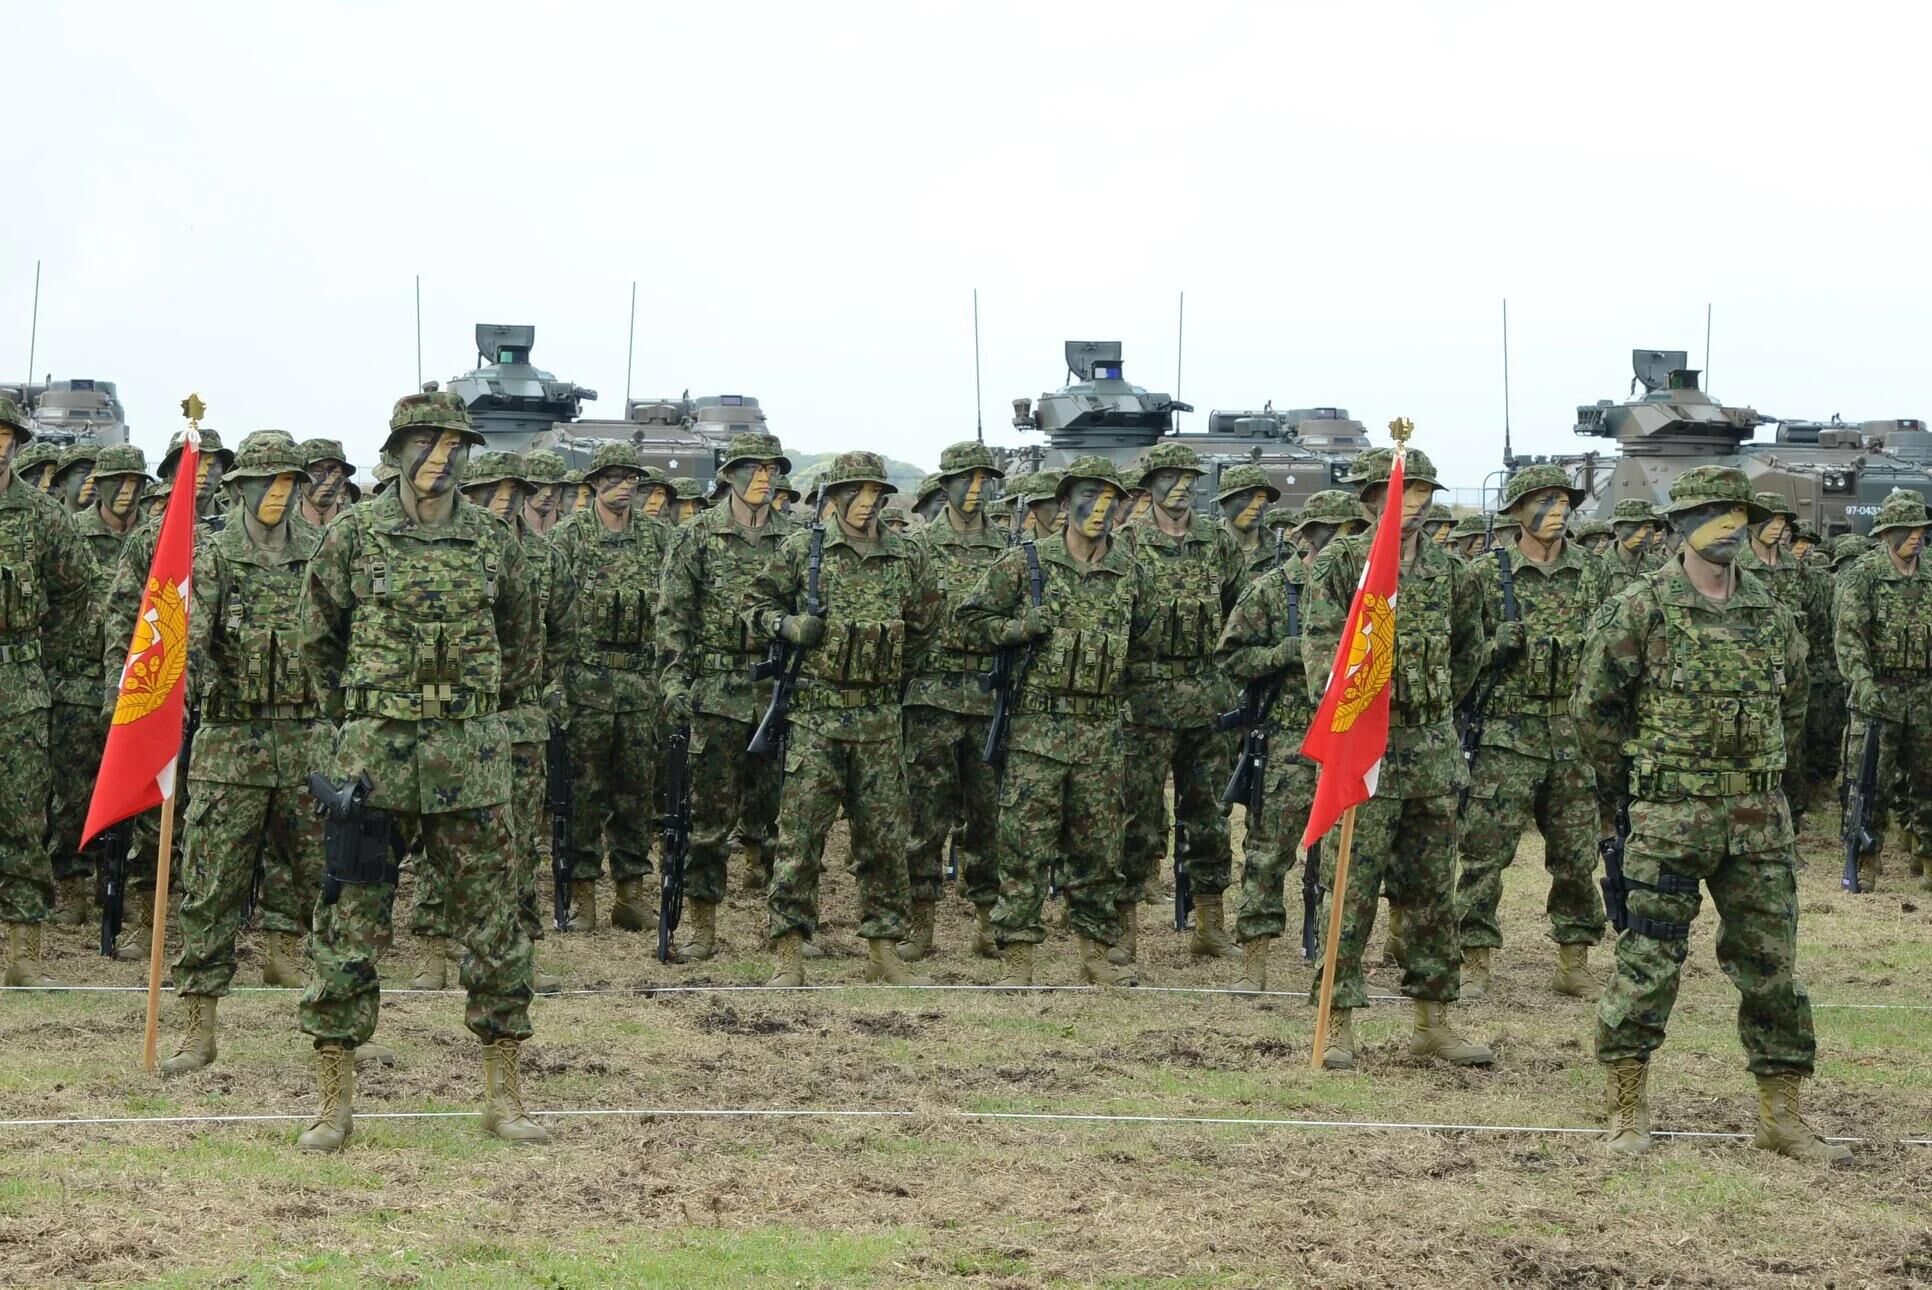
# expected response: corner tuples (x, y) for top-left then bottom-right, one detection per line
(1553, 350), (1932, 535)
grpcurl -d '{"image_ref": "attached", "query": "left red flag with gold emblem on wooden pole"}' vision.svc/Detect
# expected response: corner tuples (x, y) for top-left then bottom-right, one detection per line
(81, 431), (201, 846)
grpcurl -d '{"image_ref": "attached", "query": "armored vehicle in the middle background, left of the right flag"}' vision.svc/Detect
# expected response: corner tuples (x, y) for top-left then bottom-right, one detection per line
(1007, 340), (1368, 514)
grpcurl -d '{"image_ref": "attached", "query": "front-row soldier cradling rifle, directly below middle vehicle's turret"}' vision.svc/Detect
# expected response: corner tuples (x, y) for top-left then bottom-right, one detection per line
(958, 456), (1159, 987)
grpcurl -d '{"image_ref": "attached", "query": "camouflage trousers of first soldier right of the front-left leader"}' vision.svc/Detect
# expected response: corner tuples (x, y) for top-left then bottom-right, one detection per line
(570, 707), (657, 883)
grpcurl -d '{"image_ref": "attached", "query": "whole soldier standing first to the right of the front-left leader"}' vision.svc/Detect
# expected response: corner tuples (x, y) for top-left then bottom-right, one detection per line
(549, 440), (670, 931)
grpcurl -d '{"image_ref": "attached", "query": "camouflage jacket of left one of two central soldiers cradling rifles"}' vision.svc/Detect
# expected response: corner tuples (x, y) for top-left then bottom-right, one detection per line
(746, 521), (943, 740)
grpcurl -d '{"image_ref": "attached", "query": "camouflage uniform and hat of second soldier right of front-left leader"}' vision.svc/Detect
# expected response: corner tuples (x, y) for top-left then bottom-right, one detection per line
(657, 435), (792, 906)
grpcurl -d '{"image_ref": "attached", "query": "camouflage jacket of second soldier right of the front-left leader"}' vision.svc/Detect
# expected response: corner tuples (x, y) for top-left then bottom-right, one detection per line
(657, 502), (804, 738)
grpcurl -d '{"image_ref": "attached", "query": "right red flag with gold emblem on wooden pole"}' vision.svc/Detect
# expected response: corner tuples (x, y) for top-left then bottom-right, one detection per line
(1302, 448), (1403, 846)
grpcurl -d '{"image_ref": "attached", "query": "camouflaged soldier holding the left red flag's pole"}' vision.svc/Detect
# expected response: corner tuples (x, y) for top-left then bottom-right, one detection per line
(160, 442), (332, 1076)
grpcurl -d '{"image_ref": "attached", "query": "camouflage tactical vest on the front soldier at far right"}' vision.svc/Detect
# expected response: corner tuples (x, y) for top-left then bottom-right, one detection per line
(1631, 581), (1787, 799)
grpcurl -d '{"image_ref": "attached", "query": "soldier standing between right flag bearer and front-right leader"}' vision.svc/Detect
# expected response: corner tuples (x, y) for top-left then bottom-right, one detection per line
(1452, 465), (1611, 998)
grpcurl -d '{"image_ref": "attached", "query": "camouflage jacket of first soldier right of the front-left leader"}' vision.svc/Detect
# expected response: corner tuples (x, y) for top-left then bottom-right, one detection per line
(531, 506), (672, 713)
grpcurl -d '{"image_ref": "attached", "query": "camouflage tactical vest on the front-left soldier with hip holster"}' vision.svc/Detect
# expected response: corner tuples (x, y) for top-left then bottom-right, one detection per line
(342, 512), (508, 720)
